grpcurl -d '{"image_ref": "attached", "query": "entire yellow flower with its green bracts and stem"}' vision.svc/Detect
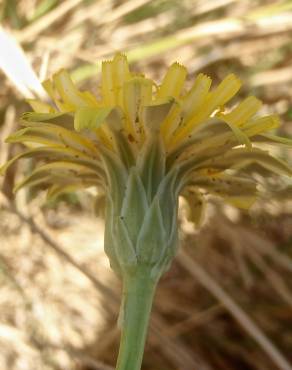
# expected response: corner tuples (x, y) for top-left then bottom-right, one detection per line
(3, 54), (292, 370)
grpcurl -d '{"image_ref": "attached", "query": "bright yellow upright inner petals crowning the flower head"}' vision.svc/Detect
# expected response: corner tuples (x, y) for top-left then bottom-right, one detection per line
(21, 53), (286, 157)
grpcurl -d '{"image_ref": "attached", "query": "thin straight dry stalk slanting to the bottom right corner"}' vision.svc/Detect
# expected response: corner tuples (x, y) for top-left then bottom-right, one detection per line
(179, 250), (292, 370)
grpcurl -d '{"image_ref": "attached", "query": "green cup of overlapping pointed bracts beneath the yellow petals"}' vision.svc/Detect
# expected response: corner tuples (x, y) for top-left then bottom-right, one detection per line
(104, 135), (182, 279)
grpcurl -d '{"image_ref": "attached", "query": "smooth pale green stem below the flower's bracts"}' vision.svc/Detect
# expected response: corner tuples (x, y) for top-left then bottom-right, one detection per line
(116, 269), (157, 370)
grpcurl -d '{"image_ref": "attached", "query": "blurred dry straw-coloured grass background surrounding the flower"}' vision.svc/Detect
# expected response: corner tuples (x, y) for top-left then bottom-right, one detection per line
(0, 0), (292, 370)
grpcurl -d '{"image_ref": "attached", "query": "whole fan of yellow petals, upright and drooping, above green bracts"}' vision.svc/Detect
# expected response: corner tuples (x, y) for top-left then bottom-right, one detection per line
(0, 53), (292, 217)
